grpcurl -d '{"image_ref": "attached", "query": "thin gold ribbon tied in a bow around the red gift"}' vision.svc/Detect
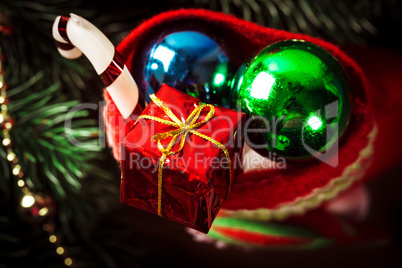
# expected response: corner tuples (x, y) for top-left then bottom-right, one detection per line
(138, 94), (232, 216)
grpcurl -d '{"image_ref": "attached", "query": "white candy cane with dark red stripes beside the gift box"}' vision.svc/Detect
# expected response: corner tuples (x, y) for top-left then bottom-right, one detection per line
(52, 13), (138, 119)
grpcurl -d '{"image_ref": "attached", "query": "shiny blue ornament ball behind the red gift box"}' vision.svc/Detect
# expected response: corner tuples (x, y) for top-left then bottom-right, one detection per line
(144, 31), (234, 107)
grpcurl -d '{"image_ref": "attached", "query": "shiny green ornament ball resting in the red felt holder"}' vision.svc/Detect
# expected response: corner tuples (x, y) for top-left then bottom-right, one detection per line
(230, 40), (352, 160)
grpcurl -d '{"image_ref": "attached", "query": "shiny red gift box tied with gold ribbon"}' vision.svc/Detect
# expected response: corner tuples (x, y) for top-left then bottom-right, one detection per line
(120, 85), (245, 233)
